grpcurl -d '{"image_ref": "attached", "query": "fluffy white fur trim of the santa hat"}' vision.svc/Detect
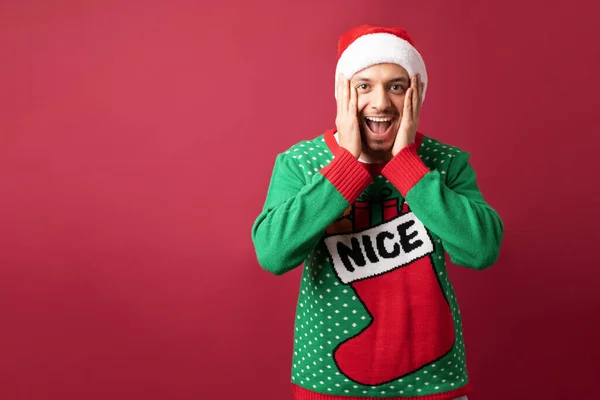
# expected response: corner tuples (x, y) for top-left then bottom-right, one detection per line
(335, 32), (428, 100)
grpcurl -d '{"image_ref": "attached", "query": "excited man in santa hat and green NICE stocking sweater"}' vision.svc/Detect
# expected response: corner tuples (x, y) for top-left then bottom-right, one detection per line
(252, 25), (503, 400)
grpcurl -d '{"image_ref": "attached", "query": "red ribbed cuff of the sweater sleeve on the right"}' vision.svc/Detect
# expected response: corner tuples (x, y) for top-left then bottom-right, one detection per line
(381, 143), (429, 198)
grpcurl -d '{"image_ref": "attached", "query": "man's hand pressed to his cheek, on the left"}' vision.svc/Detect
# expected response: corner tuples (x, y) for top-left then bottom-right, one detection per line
(335, 73), (362, 159)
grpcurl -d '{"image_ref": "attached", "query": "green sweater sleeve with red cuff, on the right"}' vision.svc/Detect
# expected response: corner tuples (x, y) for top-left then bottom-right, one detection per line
(382, 144), (504, 269)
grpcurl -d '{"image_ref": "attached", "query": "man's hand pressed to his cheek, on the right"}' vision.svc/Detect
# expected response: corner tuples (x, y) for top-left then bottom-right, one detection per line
(392, 74), (424, 156)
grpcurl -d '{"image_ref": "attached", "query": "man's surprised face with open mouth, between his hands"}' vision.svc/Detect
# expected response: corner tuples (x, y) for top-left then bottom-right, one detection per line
(350, 64), (410, 159)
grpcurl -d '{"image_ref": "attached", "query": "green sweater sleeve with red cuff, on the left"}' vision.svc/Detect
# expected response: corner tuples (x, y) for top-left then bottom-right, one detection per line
(252, 148), (372, 275)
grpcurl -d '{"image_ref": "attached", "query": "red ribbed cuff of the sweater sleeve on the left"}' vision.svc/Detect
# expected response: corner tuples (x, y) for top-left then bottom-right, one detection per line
(320, 147), (373, 203)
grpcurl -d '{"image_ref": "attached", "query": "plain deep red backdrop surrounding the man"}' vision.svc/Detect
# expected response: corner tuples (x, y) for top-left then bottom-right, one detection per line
(0, 0), (600, 400)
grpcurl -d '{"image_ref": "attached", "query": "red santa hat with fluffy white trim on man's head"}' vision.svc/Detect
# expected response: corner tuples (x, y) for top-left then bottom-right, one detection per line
(335, 25), (427, 100)
